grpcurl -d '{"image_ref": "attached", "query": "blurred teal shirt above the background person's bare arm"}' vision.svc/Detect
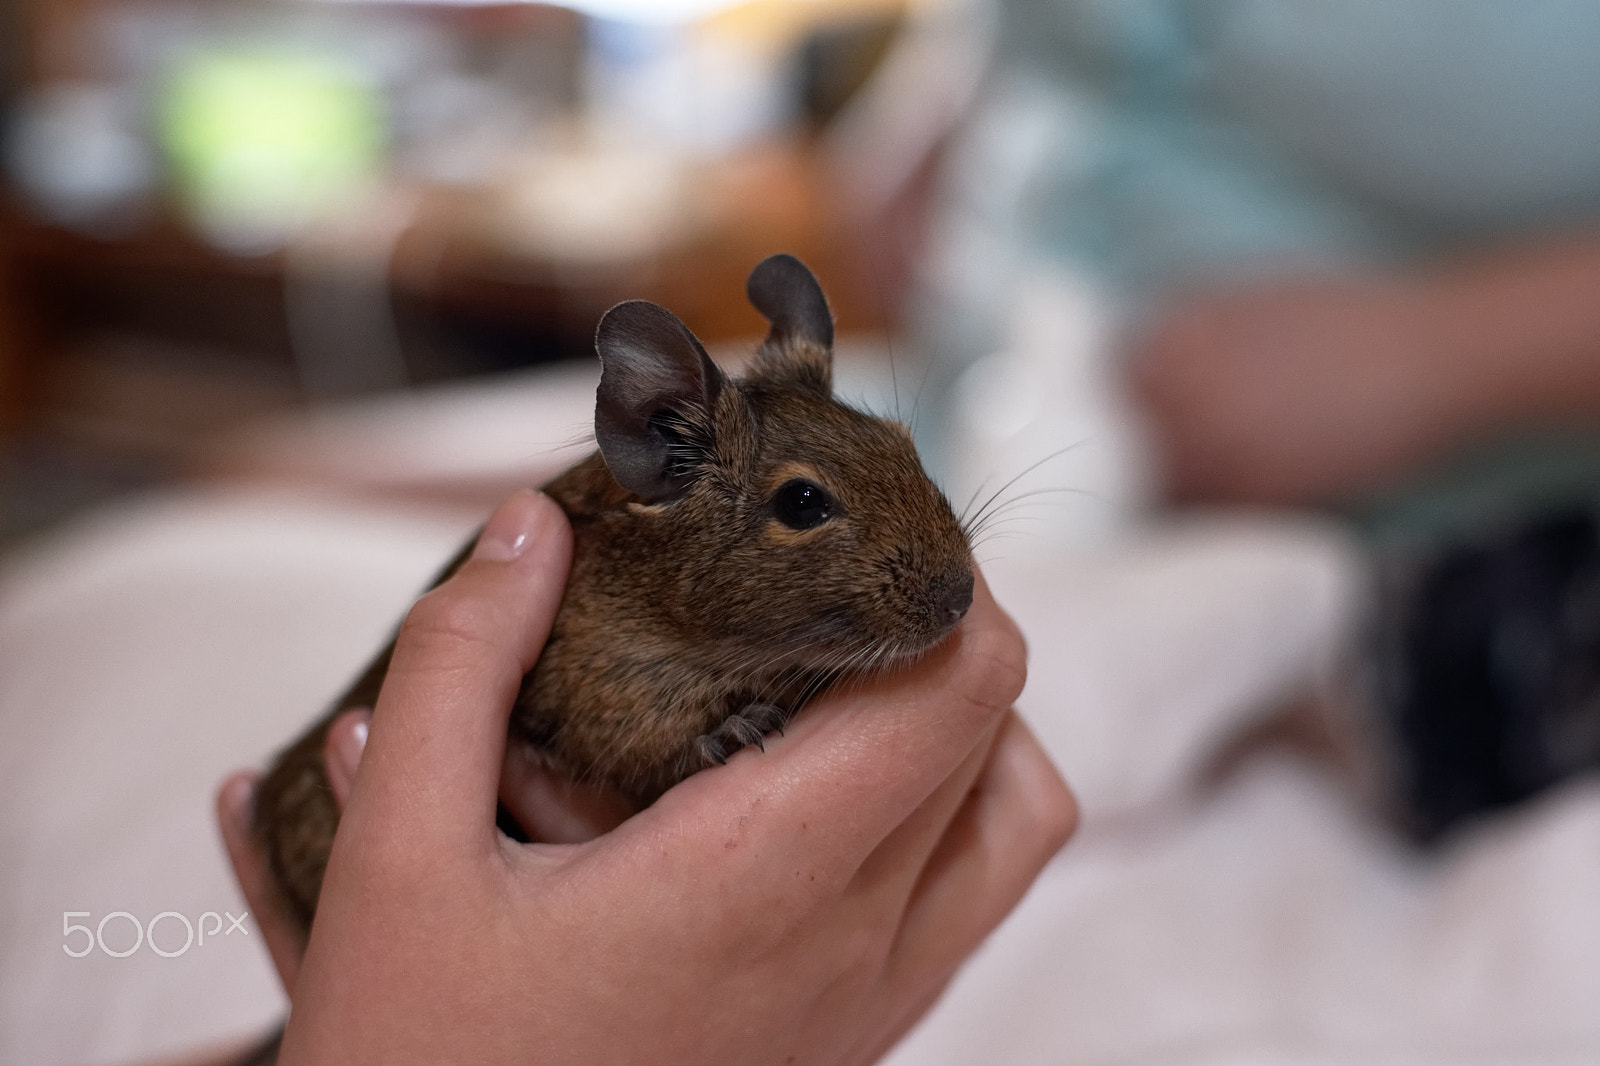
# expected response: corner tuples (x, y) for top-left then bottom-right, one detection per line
(989, 0), (1600, 296)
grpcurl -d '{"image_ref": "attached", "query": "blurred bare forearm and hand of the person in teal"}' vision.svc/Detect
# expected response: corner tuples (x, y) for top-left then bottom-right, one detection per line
(1133, 235), (1600, 504)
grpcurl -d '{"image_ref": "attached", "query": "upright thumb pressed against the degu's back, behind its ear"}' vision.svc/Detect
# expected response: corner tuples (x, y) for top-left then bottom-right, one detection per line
(341, 491), (571, 856)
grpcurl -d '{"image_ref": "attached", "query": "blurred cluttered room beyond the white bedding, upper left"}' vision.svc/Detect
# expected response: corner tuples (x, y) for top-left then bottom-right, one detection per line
(0, 0), (939, 538)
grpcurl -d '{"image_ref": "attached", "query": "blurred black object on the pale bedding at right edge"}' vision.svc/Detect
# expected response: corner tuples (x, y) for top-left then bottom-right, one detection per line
(1386, 507), (1600, 840)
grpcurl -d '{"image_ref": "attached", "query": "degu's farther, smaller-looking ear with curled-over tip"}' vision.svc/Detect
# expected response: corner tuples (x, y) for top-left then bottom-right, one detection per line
(744, 254), (834, 392)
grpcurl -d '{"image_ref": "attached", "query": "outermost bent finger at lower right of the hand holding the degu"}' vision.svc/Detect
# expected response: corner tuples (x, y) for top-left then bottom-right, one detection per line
(886, 714), (1078, 989)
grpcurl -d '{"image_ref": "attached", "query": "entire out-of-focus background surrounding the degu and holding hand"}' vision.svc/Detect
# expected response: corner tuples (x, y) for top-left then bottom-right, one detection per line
(9, 0), (1600, 1066)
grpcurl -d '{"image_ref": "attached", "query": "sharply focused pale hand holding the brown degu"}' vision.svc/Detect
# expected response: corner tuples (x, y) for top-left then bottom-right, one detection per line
(218, 493), (1077, 1064)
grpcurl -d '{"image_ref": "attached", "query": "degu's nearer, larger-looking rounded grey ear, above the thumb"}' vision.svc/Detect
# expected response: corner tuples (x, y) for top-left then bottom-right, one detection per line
(595, 299), (723, 503)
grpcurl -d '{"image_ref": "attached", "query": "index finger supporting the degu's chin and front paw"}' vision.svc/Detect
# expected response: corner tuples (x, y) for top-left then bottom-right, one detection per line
(646, 563), (1027, 888)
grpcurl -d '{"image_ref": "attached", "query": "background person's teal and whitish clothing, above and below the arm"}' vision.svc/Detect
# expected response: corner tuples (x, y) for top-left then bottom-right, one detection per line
(915, 0), (1600, 521)
